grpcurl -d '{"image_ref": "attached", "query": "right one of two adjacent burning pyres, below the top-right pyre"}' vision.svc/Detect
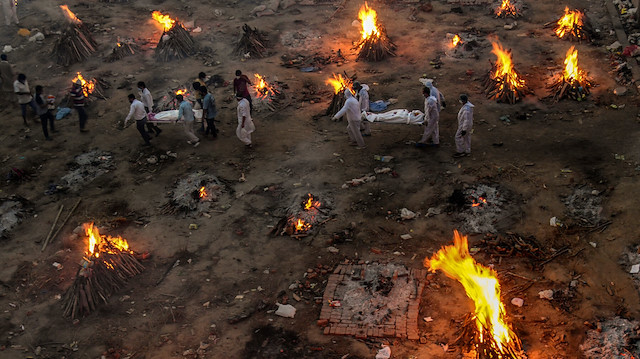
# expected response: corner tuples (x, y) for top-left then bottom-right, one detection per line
(548, 46), (593, 101)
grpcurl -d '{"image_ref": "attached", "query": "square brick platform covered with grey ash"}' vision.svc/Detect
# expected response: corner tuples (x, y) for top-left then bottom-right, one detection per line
(318, 263), (427, 340)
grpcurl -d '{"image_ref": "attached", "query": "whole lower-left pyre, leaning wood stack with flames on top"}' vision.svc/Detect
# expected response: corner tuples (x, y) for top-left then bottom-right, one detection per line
(62, 223), (144, 319)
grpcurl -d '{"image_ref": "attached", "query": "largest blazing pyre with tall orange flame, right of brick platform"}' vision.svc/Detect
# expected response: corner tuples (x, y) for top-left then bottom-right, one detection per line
(424, 231), (525, 359)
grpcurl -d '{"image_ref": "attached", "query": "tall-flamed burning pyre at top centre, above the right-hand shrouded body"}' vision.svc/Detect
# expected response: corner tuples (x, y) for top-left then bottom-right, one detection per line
(354, 2), (396, 61)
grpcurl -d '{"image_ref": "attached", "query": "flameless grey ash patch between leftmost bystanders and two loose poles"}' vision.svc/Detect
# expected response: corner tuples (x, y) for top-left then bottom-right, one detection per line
(57, 150), (116, 192)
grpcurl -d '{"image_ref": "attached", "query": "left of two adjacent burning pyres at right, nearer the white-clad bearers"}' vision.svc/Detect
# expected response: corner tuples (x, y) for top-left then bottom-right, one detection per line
(484, 42), (532, 104)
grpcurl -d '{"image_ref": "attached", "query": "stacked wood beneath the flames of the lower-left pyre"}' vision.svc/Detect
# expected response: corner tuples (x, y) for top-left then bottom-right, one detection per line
(62, 252), (144, 319)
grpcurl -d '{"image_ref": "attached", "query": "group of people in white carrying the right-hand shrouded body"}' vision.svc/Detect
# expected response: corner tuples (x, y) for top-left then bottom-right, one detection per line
(333, 80), (474, 157)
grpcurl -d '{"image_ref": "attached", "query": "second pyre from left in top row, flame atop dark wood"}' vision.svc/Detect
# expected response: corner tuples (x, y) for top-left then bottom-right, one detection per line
(151, 11), (195, 62)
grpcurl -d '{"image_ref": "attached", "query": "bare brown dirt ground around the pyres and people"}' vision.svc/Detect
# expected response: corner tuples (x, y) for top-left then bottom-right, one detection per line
(0, 0), (640, 358)
